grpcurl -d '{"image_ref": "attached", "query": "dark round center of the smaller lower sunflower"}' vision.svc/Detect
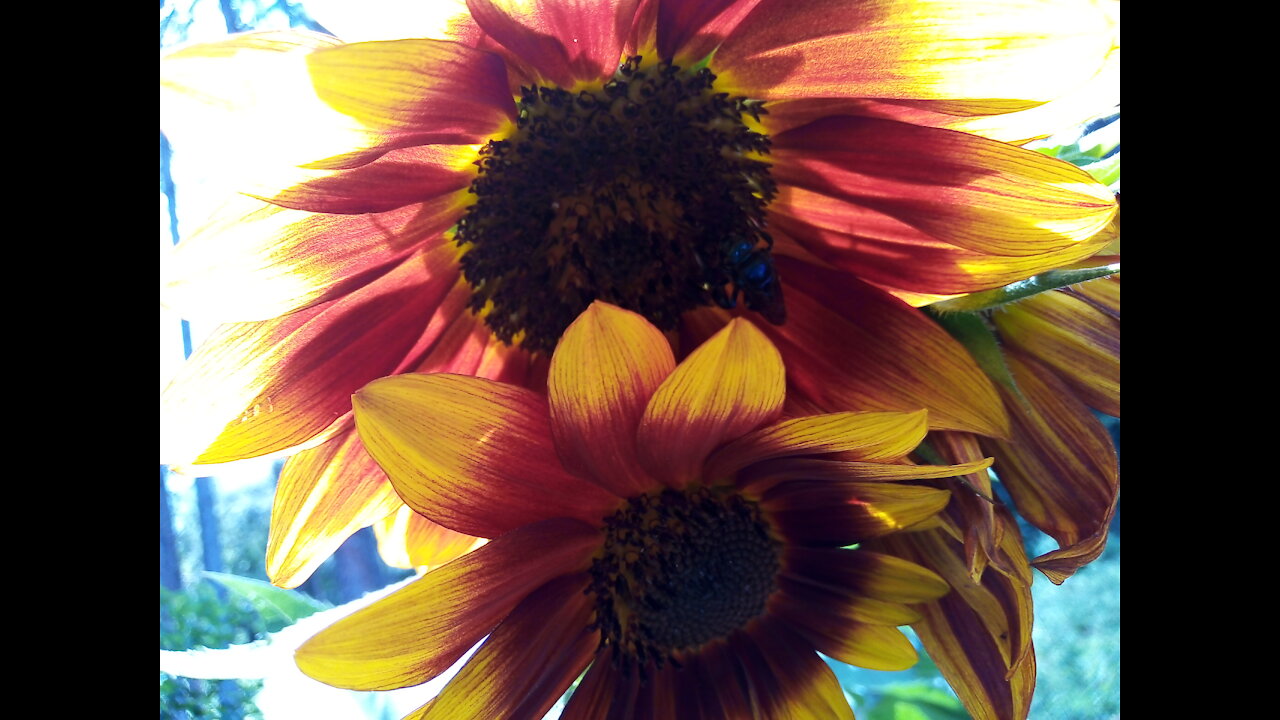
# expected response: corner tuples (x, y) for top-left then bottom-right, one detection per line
(588, 487), (782, 667)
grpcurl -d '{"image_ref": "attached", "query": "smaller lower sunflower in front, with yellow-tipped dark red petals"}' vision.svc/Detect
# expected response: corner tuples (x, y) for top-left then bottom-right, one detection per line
(296, 301), (989, 719)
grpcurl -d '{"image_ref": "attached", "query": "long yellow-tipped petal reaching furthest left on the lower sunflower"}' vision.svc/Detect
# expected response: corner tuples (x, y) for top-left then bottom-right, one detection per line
(294, 518), (600, 691)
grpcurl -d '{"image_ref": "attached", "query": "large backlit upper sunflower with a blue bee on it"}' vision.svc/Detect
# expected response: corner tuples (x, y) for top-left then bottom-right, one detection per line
(161, 0), (1116, 587)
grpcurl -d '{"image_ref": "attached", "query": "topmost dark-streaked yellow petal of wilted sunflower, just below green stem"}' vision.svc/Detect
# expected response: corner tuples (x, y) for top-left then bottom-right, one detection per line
(991, 283), (1120, 418)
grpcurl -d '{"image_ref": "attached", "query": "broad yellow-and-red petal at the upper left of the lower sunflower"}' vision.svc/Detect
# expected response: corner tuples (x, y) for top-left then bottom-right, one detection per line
(352, 374), (618, 538)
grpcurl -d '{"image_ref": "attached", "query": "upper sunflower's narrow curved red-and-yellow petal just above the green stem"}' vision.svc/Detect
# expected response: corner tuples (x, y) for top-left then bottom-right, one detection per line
(769, 186), (1107, 295)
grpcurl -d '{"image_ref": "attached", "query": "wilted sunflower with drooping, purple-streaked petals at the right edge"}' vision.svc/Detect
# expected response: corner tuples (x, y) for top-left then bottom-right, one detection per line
(869, 254), (1120, 720)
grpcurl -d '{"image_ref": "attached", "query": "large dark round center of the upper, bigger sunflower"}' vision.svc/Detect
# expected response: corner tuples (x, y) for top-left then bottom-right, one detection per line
(456, 56), (786, 352)
